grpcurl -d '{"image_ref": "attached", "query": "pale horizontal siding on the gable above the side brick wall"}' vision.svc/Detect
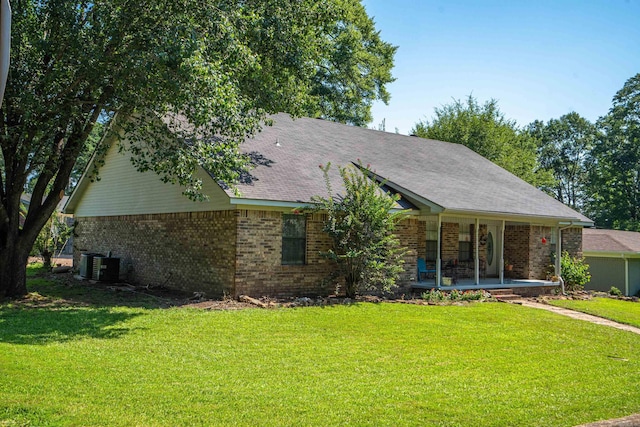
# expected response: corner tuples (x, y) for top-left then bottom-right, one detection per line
(74, 144), (231, 217)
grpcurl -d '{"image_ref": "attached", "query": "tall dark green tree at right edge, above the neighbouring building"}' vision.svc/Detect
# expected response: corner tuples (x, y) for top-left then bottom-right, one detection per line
(586, 74), (640, 231)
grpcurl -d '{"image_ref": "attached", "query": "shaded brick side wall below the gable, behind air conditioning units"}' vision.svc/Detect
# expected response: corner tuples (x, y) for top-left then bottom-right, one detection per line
(74, 211), (236, 297)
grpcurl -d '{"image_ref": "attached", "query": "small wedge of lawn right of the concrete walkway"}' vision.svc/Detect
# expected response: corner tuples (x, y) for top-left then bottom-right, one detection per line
(549, 298), (640, 328)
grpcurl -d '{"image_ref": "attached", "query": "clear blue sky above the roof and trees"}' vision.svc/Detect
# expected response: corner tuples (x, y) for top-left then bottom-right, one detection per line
(363, 0), (640, 134)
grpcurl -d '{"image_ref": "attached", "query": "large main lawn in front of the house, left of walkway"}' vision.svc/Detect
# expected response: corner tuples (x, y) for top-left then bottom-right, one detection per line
(0, 270), (640, 426)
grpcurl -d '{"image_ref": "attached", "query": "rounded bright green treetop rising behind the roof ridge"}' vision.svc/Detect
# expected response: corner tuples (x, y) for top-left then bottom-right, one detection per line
(412, 95), (551, 187)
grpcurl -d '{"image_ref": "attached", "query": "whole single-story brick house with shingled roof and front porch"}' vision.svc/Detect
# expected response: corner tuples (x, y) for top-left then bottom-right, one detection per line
(66, 113), (592, 297)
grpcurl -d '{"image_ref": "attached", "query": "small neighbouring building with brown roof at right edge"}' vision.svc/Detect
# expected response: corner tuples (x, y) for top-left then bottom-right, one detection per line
(583, 228), (640, 296)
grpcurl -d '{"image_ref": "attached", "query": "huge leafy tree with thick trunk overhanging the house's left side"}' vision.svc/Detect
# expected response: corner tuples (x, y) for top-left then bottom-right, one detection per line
(0, 0), (395, 297)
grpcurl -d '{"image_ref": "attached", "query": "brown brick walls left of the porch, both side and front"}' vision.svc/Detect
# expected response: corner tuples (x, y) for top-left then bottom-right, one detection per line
(74, 210), (424, 297)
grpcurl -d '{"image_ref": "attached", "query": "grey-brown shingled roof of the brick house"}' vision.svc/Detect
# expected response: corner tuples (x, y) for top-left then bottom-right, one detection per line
(226, 113), (591, 224)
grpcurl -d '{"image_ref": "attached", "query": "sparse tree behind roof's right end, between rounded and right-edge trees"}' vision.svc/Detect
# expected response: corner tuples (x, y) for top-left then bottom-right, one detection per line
(528, 112), (597, 211)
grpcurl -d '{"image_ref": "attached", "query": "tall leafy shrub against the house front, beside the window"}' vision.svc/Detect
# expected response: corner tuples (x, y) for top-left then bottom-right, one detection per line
(312, 163), (405, 298)
